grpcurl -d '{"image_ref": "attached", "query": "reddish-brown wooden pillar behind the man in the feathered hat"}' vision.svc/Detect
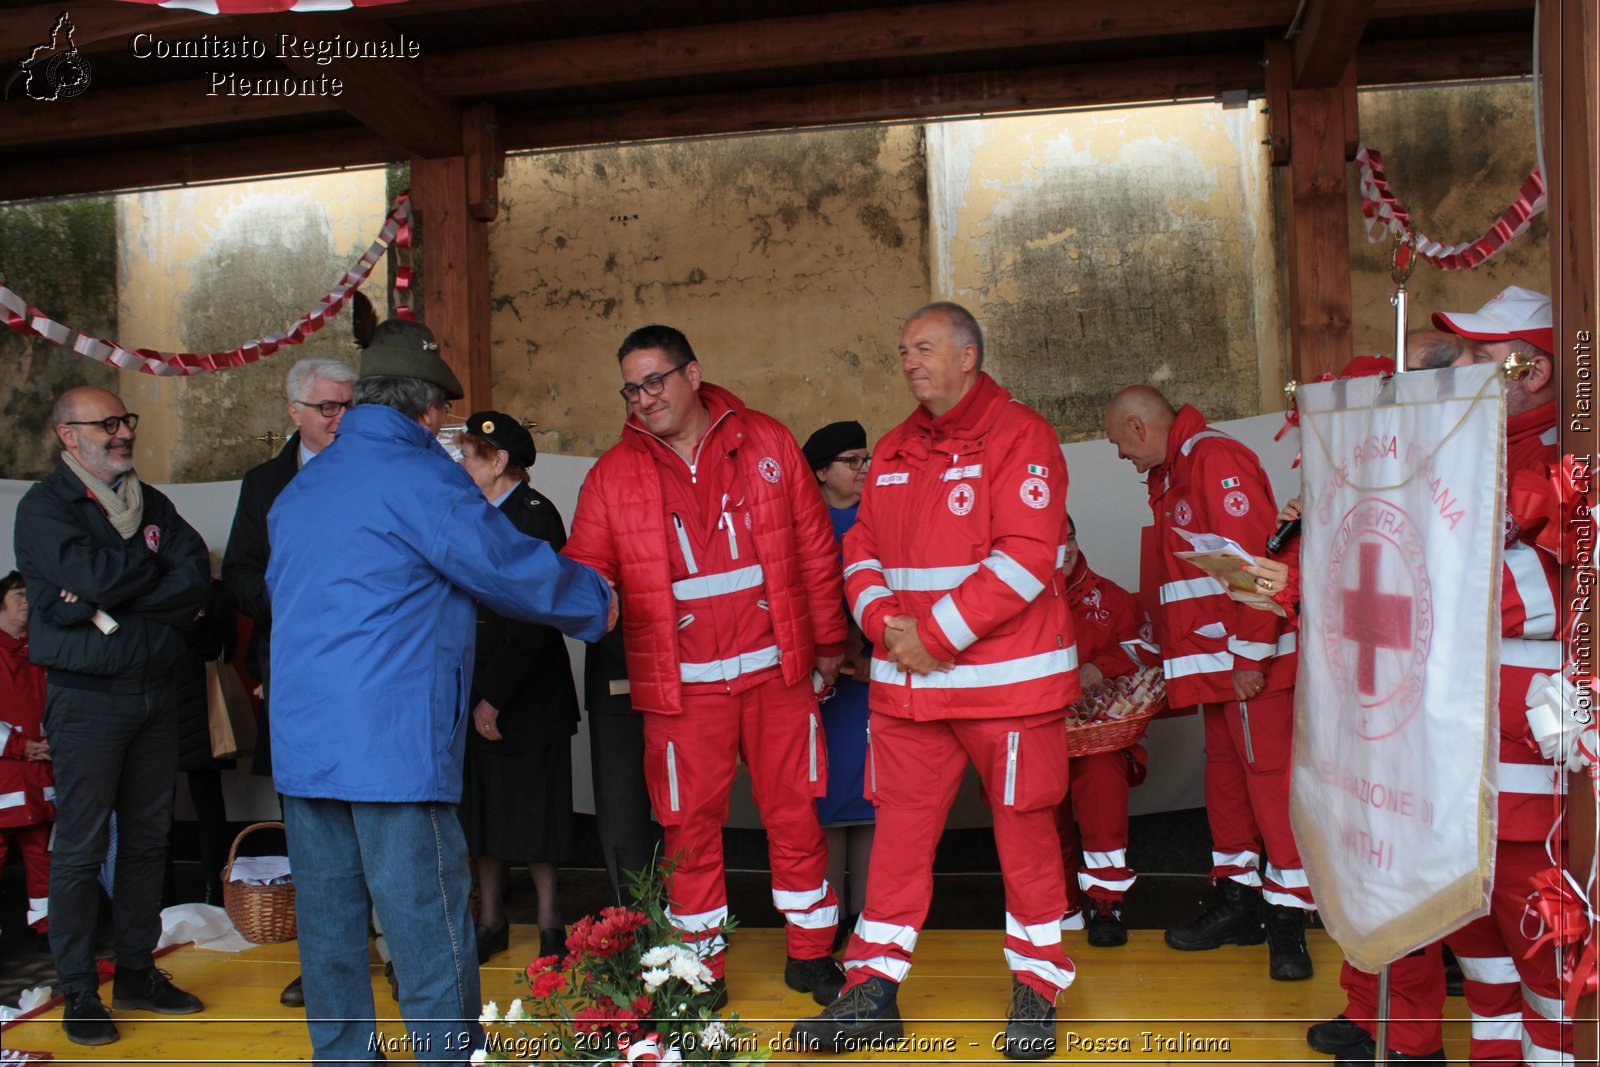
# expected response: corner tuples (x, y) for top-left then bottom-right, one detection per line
(411, 155), (493, 416)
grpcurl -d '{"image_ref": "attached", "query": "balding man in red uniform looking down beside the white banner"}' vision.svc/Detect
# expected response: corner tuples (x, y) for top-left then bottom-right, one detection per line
(1106, 386), (1312, 981)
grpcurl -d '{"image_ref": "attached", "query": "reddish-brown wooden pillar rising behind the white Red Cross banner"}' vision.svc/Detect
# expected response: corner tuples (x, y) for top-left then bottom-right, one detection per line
(1267, 75), (1354, 382)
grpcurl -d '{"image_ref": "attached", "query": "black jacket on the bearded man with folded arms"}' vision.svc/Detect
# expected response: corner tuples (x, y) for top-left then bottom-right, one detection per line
(16, 461), (211, 681)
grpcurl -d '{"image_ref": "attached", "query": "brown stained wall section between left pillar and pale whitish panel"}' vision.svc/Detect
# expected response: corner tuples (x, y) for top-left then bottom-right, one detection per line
(490, 126), (928, 456)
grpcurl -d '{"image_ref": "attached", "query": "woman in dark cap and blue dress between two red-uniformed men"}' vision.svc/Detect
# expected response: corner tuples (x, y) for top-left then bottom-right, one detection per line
(800, 422), (877, 947)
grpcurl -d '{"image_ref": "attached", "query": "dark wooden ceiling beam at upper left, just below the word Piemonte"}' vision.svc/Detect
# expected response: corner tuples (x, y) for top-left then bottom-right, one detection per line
(0, 80), (344, 147)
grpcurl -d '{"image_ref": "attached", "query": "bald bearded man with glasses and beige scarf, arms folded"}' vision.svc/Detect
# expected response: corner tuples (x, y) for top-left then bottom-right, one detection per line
(16, 387), (211, 1045)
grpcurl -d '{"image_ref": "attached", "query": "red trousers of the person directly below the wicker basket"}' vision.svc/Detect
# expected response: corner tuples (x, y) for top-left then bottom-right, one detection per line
(1056, 745), (1149, 929)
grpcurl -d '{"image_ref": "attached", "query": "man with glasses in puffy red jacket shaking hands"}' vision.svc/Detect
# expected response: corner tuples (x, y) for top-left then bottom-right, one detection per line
(562, 326), (845, 1005)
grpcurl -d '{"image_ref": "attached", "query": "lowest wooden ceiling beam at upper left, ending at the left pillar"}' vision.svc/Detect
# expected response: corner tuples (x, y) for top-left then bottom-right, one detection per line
(0, 126), (406, 200)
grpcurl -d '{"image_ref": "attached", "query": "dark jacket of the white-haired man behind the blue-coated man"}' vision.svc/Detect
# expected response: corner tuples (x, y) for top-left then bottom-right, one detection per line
(222, 434), (299, 774)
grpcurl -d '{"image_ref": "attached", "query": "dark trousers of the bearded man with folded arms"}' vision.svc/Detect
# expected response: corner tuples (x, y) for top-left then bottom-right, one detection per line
(45, 680), (178, 995)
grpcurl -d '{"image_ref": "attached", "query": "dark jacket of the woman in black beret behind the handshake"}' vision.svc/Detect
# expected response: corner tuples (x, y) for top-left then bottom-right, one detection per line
(467, 485), (579, 752)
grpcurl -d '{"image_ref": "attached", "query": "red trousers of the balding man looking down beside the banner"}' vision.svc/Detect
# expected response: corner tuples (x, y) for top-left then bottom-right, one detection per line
(1200, 689), (1315, 910)
